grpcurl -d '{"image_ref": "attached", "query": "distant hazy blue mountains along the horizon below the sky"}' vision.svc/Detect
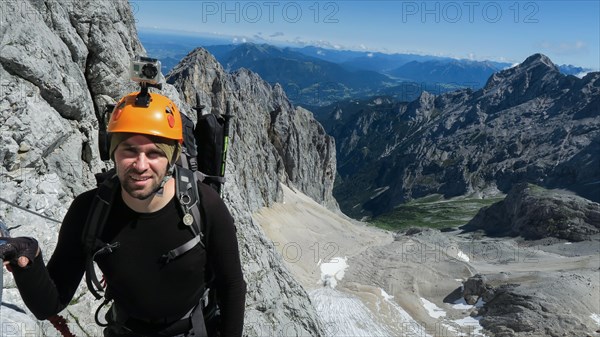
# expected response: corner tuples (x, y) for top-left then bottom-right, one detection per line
(140, 30), (586, 110)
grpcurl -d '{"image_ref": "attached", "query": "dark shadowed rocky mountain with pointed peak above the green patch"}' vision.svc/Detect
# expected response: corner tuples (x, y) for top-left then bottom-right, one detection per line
(325, 54), (600, 216)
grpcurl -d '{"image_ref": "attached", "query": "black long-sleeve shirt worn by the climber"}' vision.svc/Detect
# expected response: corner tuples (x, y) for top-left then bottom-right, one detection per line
(14, 184), (246, 336)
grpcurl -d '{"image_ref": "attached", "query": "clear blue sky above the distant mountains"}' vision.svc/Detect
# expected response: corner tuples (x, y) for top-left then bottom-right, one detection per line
(130, 0), (600, 70)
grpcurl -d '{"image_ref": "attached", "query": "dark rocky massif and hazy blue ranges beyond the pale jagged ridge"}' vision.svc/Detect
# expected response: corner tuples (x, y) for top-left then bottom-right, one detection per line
(137, 29), (600, 217)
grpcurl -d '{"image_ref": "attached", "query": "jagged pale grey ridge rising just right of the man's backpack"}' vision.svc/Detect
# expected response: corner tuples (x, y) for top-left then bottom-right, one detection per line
(167, 49), (337, 336)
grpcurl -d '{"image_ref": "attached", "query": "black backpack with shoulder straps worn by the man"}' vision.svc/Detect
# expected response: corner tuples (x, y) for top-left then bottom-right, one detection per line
(82, 94), (232, 335)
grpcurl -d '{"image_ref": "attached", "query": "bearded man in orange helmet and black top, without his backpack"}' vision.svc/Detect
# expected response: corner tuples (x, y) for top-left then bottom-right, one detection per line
(0, 93), (246, 337)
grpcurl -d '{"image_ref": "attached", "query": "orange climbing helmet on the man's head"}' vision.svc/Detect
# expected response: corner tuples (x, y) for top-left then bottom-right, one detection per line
(107, 92), (183, 143)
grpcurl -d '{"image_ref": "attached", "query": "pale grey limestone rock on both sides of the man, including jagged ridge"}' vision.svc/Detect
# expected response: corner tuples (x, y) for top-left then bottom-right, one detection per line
(0, 0), (337, 336)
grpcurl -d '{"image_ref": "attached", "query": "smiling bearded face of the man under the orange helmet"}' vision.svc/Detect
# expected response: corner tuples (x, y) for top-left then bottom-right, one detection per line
(114, 135), (169, 200)
